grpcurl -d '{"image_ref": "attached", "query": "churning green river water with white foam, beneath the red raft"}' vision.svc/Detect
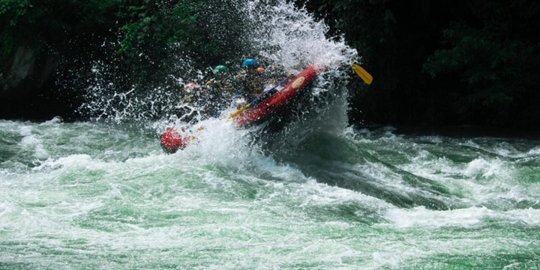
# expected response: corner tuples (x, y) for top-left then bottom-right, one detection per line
(0, 119), (540, 269)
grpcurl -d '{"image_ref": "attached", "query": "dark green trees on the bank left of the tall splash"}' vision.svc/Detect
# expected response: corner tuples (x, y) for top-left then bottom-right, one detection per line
(0, 0), (247, 117)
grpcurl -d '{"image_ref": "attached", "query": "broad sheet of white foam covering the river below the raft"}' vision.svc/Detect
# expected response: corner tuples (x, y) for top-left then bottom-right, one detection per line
(0, 119), (540, 269)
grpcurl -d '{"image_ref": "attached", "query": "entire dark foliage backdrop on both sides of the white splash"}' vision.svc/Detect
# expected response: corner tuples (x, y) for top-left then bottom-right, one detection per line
(0, 0), (540, 129)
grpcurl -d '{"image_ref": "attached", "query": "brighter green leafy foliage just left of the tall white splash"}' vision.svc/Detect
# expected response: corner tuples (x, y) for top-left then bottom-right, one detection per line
(114, 0), (251, 87)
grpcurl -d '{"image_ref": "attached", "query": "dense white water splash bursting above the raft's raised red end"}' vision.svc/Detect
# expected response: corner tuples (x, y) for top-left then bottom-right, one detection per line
(247, 0), (359, 71)
